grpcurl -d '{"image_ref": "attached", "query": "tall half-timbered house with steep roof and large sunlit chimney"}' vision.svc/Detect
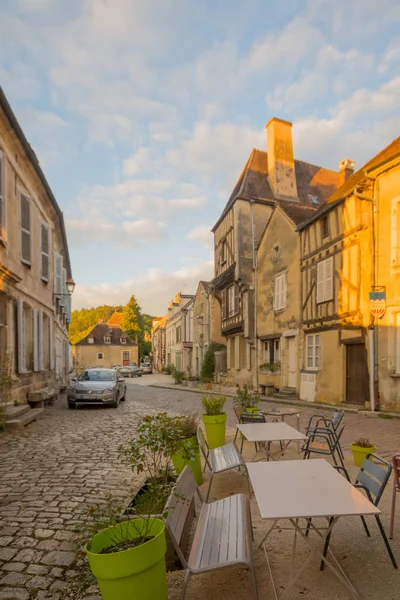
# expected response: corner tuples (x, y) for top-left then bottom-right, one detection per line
(212, 118), (339, 386)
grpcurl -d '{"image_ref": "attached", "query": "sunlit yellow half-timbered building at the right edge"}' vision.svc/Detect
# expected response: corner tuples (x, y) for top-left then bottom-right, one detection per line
(298, 138), (400, 410)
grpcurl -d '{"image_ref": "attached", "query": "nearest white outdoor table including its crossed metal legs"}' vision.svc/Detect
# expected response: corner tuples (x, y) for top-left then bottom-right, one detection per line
(247, 459), (380, 600)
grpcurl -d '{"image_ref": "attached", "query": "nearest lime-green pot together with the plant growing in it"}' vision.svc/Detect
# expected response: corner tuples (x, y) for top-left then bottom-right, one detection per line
(85, 488), (168, 600)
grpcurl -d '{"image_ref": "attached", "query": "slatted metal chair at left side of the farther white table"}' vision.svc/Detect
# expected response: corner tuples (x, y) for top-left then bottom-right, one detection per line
(197, 425), (251, 502)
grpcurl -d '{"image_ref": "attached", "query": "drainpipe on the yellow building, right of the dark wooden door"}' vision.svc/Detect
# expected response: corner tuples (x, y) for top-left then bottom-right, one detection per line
(354, 178), (379, 412)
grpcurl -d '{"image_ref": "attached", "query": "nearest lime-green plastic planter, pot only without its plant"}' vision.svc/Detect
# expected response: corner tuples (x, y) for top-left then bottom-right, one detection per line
(86, 519), (168, 600)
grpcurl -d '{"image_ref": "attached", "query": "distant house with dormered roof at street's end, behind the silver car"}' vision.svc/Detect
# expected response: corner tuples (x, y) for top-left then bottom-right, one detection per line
(75, 313), (139, 372)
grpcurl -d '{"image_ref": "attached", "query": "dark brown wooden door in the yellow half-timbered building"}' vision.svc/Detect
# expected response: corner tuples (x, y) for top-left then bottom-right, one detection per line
(346, 344), (369, 404)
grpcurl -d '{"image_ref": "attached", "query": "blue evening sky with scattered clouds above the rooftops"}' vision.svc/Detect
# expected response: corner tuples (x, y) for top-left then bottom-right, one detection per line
(0, 0), (400, 315)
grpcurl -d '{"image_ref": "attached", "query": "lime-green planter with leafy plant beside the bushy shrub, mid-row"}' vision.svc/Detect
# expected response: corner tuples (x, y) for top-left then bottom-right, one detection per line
(172, 415), (203, 485)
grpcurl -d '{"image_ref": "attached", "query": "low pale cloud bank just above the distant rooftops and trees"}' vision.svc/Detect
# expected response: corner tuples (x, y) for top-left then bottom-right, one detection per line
(73, 261), (213, 316)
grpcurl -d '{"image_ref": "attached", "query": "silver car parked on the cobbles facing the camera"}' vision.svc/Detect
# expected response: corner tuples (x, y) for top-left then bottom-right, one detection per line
(67, 367), (126, 408)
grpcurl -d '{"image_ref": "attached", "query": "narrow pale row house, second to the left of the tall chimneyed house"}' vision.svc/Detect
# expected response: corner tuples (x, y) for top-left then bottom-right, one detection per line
(165, 292), (194, 374)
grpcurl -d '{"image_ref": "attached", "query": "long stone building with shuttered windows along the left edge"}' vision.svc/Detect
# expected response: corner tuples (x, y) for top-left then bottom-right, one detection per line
(0, 88), (73, 403)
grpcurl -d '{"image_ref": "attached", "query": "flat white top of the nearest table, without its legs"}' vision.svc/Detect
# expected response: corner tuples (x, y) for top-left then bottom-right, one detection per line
(247, 459), (380, 519)
